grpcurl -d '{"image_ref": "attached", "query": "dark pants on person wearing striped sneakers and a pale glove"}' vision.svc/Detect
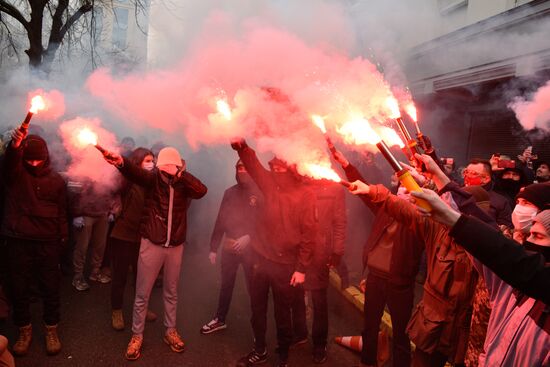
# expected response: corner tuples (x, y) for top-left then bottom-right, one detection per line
(216, 250), (252, 322)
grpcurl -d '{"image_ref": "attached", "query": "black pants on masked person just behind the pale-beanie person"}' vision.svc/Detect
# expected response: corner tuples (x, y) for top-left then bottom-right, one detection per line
(109, 237), (139, 310)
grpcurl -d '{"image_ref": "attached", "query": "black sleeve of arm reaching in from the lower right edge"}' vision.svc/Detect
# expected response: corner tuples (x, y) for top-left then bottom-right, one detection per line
(450, 215), (550, 305)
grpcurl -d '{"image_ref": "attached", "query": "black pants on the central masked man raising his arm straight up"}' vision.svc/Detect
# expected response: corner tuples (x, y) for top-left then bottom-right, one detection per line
(250, 255), (296, 357)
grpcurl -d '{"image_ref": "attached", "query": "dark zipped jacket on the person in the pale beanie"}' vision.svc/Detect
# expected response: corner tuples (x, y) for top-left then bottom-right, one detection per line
(119, 158), (207, 246)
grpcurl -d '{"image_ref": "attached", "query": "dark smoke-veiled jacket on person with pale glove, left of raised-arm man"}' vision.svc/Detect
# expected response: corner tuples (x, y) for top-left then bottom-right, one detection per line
(210, 182), (263, 252)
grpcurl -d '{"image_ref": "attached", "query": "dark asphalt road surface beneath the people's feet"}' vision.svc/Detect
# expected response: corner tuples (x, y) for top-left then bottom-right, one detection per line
(0, 242), (370, 367)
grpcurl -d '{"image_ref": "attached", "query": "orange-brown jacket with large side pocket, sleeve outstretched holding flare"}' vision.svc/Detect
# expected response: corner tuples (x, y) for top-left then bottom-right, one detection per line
(365, 185), (477, 363)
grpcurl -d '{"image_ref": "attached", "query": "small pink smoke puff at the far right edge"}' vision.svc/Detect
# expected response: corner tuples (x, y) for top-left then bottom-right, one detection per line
(508, 81), (550, 132)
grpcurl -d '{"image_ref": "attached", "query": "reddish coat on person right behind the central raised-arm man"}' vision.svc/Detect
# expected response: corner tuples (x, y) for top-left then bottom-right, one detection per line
(304, 180), (347, 290)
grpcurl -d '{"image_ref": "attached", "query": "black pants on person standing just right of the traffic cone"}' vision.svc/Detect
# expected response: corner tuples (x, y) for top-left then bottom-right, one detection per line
(361, 273), (414, 366)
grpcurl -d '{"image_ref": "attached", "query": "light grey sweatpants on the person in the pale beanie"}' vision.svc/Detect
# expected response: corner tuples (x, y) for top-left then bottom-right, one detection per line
(132, 238), (183, 335)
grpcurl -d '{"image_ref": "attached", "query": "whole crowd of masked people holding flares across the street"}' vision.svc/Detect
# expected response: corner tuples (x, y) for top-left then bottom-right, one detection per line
(0, 123), (550, 367)
